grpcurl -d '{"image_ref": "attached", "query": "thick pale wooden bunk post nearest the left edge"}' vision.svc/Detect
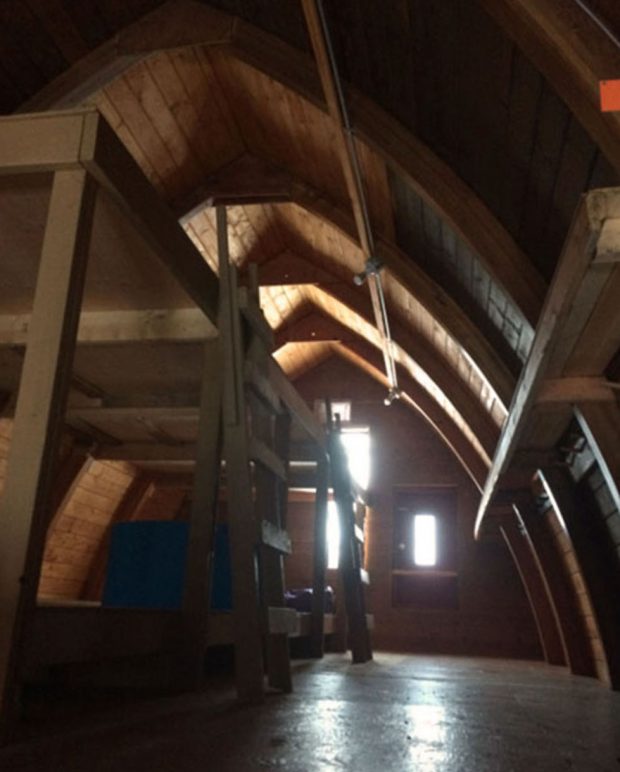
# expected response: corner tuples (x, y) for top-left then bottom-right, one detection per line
(0, 170), (95, 740)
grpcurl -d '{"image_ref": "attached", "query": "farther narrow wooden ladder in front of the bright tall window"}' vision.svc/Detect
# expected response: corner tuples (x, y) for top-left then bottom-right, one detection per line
(327, 410), (372, 663)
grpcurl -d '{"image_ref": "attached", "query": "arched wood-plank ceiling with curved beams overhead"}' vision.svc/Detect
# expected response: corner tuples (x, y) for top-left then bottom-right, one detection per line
(0, 0), (620, 486)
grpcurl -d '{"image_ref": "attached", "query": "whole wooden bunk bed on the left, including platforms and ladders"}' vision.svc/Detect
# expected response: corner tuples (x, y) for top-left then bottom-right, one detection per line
(0, 110), (370, 712)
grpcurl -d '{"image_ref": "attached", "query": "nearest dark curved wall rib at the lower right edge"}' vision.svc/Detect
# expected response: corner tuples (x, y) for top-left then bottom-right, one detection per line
(539, 467), (620, 689)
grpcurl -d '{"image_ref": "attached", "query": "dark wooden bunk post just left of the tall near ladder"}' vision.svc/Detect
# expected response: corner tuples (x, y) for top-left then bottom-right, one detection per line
(180, 338), (222, 688)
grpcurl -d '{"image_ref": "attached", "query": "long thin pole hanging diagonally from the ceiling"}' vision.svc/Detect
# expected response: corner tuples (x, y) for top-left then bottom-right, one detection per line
(302, 0), (400, 405)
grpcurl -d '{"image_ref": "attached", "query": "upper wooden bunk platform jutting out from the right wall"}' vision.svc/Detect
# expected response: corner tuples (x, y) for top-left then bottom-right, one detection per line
(475, 188), (620, 537)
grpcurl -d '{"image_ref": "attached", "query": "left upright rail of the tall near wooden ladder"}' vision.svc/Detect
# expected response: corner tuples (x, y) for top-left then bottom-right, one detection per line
(216, 206), (264, 701)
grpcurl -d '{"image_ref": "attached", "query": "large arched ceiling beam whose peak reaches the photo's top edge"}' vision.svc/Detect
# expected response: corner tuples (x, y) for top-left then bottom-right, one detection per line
(17, 0), (545, 326)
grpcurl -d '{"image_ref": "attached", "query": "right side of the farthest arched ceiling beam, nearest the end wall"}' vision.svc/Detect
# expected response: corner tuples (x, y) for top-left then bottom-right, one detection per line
(334, 341), (488, 490)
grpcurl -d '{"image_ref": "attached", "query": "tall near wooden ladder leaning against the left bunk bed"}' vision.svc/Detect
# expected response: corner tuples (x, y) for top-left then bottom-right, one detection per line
(216, 207), (297, 701)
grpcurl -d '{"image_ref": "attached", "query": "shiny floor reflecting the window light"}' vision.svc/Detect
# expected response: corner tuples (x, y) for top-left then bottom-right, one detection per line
(0, 653), (620, 772)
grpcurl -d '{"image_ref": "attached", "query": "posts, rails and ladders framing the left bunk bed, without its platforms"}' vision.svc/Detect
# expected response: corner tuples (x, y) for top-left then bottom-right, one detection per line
(0, 110), (370, 736)
